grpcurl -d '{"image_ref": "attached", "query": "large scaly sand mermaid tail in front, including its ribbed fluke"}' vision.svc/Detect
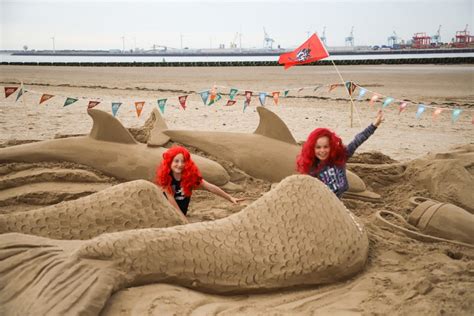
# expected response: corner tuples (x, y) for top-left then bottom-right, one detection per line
(0, 175), (368, 315)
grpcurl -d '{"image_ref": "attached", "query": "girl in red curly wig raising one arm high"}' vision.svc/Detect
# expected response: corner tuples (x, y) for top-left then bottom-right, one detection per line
(296, 110), (384, 198)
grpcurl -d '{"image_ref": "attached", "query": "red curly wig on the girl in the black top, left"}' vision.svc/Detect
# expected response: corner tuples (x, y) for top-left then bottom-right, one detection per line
(155, 146), (202, 196)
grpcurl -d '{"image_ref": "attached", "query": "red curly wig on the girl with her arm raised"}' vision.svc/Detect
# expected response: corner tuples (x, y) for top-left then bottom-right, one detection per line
(296, 128), (347, 174)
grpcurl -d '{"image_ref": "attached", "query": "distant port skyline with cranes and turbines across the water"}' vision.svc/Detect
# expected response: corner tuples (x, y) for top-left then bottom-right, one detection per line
(8, 25), (474, 56)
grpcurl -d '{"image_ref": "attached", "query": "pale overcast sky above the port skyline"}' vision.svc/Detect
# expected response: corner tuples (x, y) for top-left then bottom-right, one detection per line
(0, 0), (474, 50)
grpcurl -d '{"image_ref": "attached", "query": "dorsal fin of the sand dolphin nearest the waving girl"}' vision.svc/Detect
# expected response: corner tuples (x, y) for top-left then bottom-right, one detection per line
(254, 106), (297, 145)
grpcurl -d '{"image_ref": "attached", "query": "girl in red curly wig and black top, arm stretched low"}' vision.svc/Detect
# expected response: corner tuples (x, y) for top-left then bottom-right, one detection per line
(155, 146), (243, 215)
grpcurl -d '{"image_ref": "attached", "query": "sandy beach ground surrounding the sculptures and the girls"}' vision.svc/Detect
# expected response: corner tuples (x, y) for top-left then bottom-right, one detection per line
(0, 65), (474, 315)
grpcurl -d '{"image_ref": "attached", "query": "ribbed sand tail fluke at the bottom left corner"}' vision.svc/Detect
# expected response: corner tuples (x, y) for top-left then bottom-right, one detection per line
(0, 234), (123, 315)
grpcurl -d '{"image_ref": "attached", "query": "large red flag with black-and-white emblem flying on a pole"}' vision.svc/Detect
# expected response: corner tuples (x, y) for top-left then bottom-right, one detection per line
(278, 34), (329, 69)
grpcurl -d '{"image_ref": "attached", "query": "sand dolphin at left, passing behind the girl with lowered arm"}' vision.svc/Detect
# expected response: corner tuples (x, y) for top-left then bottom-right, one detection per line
(0, 109), (236, 190)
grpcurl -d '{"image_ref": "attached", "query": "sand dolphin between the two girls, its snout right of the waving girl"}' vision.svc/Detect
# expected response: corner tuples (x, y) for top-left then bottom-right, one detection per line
(148, 106), (380, 201)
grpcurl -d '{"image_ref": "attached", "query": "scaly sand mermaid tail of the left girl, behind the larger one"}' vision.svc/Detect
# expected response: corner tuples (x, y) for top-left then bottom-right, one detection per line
(0, 180), (187, 239)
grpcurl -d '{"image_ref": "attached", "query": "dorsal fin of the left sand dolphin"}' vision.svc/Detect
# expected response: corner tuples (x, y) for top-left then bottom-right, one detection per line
(87, 109), (138, 144)
